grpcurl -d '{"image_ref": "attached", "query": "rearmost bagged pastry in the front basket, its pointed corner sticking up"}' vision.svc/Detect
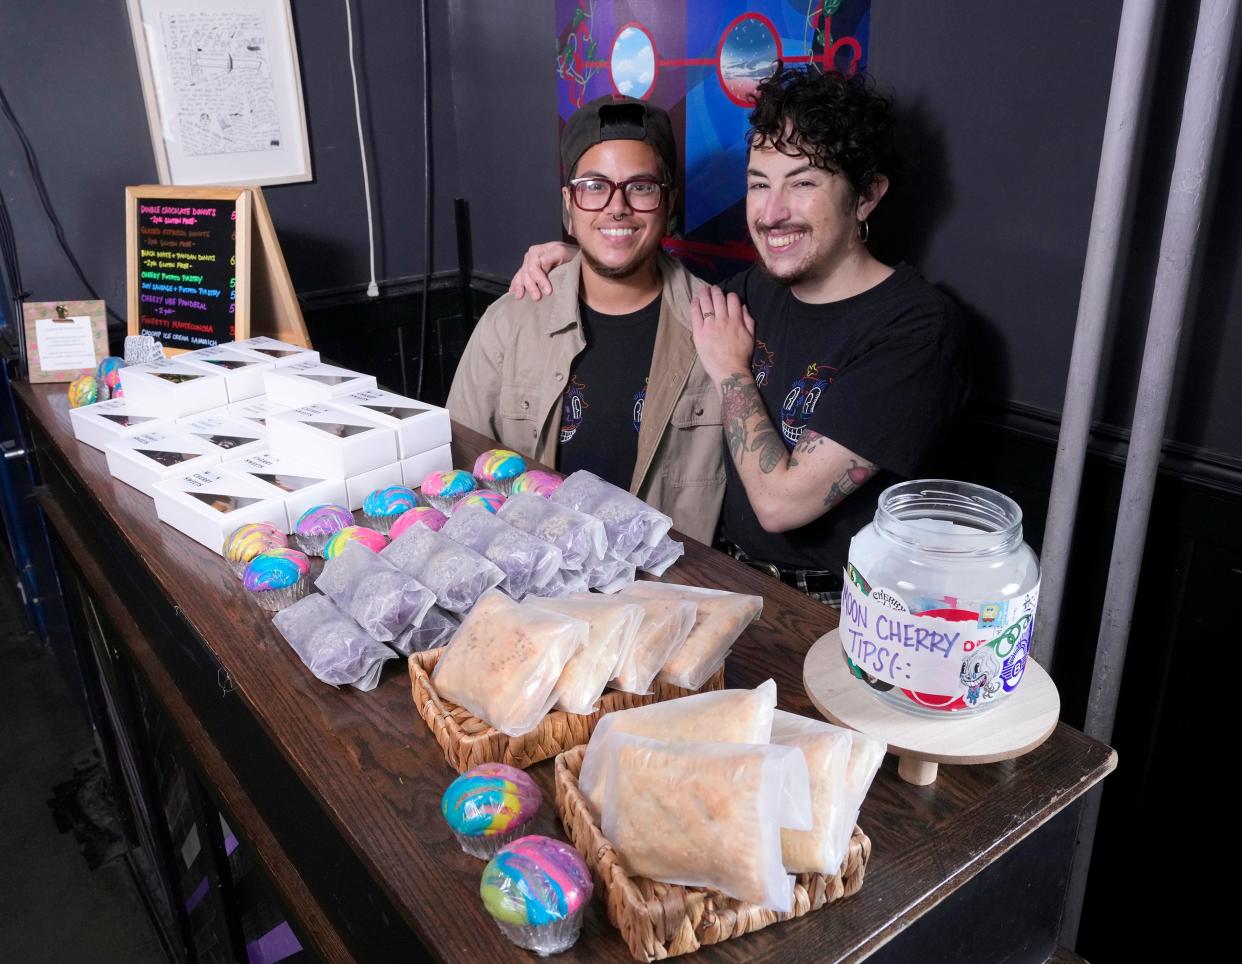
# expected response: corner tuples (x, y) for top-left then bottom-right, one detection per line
(578, 680), (776, 816)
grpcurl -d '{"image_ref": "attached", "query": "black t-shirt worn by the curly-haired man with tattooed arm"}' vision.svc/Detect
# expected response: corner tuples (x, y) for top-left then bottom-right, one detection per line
(722, 265), (968, 573)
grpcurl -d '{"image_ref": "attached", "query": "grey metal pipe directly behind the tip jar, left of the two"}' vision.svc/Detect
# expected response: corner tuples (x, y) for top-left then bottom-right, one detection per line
(1033, 0), (1161, 670)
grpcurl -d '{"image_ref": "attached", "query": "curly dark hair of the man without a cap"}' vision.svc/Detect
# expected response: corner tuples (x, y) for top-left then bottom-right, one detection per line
(746, 66), (900, 194)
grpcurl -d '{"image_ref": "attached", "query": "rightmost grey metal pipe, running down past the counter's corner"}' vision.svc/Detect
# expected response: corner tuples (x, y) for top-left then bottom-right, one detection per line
(1062, 0), (1238, 945)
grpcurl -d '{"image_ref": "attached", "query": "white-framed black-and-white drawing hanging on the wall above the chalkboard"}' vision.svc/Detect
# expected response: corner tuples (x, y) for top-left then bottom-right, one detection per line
(127, 0), (312, 185)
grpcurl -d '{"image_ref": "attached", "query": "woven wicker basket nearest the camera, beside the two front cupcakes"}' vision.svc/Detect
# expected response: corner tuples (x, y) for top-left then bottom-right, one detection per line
(556, 747), (871, 960)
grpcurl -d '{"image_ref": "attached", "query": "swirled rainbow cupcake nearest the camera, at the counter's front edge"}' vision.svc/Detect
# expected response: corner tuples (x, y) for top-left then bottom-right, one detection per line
(478, 835), (594, 955)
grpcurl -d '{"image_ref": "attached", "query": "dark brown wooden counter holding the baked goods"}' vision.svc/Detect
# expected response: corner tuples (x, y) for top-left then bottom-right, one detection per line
(16, 384), (1115, 962)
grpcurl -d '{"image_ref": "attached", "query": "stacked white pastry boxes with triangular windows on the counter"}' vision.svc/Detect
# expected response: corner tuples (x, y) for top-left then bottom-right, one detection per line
(71, 337), (452, 553)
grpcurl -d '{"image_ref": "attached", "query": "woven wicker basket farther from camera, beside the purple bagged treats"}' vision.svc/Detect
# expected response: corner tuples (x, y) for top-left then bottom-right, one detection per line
(410, 648), (724, 773)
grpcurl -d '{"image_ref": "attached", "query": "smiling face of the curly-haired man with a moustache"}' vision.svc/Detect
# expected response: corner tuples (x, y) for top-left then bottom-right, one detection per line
(746, 135), (887, 301)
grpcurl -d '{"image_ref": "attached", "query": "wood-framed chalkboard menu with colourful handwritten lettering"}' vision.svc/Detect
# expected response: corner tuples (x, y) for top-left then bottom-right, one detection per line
(125, 186), (251, 352)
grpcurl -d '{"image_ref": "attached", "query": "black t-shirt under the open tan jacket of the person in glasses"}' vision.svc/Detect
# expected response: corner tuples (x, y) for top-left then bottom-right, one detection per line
(556, 294), (661, 489)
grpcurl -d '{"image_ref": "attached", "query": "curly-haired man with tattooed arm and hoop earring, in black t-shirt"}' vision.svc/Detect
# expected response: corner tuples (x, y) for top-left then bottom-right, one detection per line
(514, 68), (966, 604)
